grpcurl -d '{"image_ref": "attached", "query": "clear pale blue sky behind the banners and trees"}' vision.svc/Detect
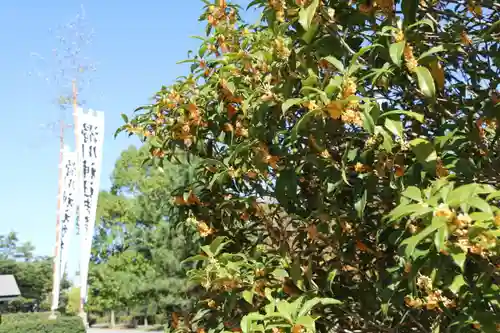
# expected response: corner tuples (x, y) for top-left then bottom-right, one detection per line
(0, 0), (258, 269)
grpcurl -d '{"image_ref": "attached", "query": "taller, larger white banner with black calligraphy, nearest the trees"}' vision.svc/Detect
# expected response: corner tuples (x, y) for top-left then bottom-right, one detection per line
(75, 108), (104, 305)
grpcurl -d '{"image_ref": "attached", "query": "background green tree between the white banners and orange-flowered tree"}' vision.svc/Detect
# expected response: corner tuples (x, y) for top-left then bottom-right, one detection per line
(89, 146), (197, 323)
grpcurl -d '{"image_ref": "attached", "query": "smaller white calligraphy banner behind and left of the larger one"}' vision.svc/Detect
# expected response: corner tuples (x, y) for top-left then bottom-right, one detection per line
(59, 147), (77, 279)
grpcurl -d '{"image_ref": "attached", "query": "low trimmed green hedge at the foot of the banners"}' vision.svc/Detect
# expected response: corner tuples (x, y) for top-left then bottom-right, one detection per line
(0, 313), (85, 333)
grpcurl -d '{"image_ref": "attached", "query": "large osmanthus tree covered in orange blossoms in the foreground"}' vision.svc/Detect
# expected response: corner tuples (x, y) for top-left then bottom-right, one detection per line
(119, 0), (500, 333)
